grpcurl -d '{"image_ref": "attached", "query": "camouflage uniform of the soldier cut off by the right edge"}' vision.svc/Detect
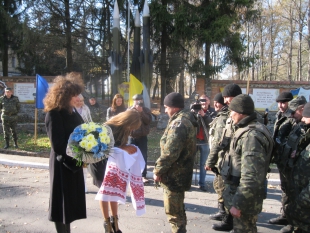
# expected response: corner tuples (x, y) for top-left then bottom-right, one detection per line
(284, 125), (310, 232)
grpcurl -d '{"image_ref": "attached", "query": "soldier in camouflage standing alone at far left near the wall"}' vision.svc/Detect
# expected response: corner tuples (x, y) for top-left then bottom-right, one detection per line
(0, 87), (20, 149)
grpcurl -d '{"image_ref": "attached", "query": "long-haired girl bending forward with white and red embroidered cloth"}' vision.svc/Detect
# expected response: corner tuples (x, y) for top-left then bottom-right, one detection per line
(89, 110), (144, 233)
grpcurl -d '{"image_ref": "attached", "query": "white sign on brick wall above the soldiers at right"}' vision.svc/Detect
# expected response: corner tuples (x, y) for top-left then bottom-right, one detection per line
(251, 88), (279, 111)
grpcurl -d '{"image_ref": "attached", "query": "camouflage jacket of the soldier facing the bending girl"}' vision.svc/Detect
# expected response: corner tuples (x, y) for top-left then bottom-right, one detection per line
(153, 110), (197, 192)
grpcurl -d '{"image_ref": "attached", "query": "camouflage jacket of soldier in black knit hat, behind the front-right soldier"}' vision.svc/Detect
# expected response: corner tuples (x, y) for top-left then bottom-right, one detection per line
(205, 106), (229, 167)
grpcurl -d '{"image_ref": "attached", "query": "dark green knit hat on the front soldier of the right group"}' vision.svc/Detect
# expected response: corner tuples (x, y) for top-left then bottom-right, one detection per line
(229, 94), (254, 115)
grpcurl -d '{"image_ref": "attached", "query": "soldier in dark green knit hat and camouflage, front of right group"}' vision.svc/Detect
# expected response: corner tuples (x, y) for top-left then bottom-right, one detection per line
(221, 94), (273, 233)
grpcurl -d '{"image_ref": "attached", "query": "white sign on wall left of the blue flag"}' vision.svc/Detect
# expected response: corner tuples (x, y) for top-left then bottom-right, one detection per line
(14, 83), (36, 103)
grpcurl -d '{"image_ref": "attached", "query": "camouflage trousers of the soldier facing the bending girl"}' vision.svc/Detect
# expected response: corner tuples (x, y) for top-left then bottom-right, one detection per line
(164, 189), (187, 233)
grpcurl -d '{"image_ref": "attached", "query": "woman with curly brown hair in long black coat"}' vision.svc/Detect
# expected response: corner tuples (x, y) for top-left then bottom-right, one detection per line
(44, 72), (86, 233)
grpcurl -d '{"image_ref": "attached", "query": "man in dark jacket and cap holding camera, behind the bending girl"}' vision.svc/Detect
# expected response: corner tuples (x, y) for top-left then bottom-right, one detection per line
(129, 95), (152, 183)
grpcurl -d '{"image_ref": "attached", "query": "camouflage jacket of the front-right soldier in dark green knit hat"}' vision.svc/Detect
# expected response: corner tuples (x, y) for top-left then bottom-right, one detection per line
(222, 113), (273, 214)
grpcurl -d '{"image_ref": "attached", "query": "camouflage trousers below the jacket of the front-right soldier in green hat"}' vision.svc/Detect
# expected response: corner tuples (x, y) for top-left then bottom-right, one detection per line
(234, 213), (257, 233)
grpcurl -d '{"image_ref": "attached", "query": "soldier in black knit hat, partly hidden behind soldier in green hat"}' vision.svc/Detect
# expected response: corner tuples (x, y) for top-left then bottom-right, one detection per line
(205, 84), (242, 231)
